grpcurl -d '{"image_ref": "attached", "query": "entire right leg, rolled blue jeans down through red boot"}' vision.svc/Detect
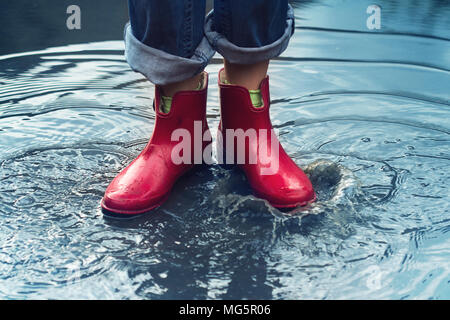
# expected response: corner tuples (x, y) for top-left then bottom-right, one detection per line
(205, 0), (315, 208)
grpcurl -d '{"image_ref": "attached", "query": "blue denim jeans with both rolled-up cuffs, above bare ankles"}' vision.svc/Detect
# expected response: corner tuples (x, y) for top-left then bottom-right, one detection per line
(125, 0), (294, 85)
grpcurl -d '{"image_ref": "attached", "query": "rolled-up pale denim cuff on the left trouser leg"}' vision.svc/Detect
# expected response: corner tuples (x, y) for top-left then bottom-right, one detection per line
(124, 23), (215, 85)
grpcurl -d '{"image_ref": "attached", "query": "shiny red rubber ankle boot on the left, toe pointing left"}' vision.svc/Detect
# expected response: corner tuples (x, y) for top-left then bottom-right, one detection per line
(101, 73), (208, 217)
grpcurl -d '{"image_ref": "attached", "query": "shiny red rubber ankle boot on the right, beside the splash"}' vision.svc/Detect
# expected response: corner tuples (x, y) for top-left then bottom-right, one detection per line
(218, 71), (316, 208)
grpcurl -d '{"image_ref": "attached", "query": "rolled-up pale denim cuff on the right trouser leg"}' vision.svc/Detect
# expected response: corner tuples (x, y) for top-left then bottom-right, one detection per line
(205, 5), (295, 64)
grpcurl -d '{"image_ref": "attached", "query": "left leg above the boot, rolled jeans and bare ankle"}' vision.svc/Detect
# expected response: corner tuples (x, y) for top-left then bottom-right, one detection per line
(125, 0), (215, 96)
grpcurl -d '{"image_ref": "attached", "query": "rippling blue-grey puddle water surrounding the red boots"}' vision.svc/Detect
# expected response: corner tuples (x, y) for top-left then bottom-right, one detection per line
(0, 1), (450, 299)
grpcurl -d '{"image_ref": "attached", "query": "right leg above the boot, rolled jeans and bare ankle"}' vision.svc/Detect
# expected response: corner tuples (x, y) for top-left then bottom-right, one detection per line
(207, 0), (294, 90)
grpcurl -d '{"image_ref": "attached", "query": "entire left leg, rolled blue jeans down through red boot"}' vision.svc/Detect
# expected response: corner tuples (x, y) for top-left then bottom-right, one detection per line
(101, 0), (214, 217)
